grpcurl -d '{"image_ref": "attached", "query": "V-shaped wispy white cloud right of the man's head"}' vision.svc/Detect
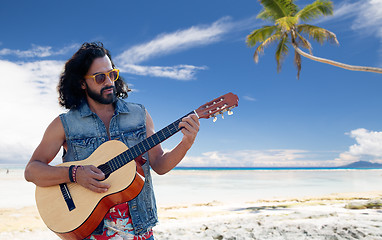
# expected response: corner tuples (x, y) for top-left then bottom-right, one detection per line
(115, 17), (255, 80)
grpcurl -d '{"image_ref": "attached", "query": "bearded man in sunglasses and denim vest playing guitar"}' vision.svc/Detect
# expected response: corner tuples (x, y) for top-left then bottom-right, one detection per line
(25, 43), (199, 239)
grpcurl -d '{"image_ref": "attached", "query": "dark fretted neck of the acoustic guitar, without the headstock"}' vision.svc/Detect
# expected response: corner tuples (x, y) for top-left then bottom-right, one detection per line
(99, 111), (195, 175)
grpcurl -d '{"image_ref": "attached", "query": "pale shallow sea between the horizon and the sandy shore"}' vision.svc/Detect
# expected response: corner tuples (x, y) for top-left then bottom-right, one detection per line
(0, 165), (382, 208)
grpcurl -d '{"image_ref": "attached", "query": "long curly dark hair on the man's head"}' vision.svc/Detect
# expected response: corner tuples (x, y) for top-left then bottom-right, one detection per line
(57, 42), (131, 109)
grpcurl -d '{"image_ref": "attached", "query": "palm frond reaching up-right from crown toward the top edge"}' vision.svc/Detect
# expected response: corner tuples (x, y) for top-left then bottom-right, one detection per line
(296, 0), (333, 22)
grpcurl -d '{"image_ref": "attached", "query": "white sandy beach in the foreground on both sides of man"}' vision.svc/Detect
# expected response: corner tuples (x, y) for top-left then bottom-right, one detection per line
(0, 168), (382, 240)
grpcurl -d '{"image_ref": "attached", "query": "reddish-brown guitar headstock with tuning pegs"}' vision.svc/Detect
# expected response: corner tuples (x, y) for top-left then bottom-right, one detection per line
(195, 93), (239, 122)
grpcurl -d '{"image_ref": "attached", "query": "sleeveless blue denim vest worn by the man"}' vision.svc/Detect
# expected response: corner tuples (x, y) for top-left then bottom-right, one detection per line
(60, 99), (158, 235)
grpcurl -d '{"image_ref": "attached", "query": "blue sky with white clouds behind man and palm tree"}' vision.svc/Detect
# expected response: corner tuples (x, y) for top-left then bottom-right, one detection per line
(0, 0), (382, 167)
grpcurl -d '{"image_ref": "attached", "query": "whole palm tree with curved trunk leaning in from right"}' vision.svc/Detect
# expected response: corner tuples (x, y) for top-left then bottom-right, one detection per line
(247, 0), (382, 78)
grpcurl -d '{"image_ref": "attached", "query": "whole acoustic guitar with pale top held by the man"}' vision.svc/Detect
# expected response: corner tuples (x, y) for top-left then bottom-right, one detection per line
(36, 93), (239, 240)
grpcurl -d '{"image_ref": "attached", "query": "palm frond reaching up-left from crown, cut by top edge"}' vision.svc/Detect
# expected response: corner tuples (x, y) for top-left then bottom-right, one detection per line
(258, 0), (298, 20)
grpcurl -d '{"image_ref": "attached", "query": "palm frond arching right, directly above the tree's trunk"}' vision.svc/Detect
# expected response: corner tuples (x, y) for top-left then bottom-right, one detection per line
(297, 24), (339, 44)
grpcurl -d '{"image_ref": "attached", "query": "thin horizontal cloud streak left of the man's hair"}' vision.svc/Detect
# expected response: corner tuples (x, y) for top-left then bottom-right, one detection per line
(0, 44), (79, 58)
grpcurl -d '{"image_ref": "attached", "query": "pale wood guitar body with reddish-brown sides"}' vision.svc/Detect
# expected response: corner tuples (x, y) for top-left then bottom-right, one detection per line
(36, 140), (144, 239)
